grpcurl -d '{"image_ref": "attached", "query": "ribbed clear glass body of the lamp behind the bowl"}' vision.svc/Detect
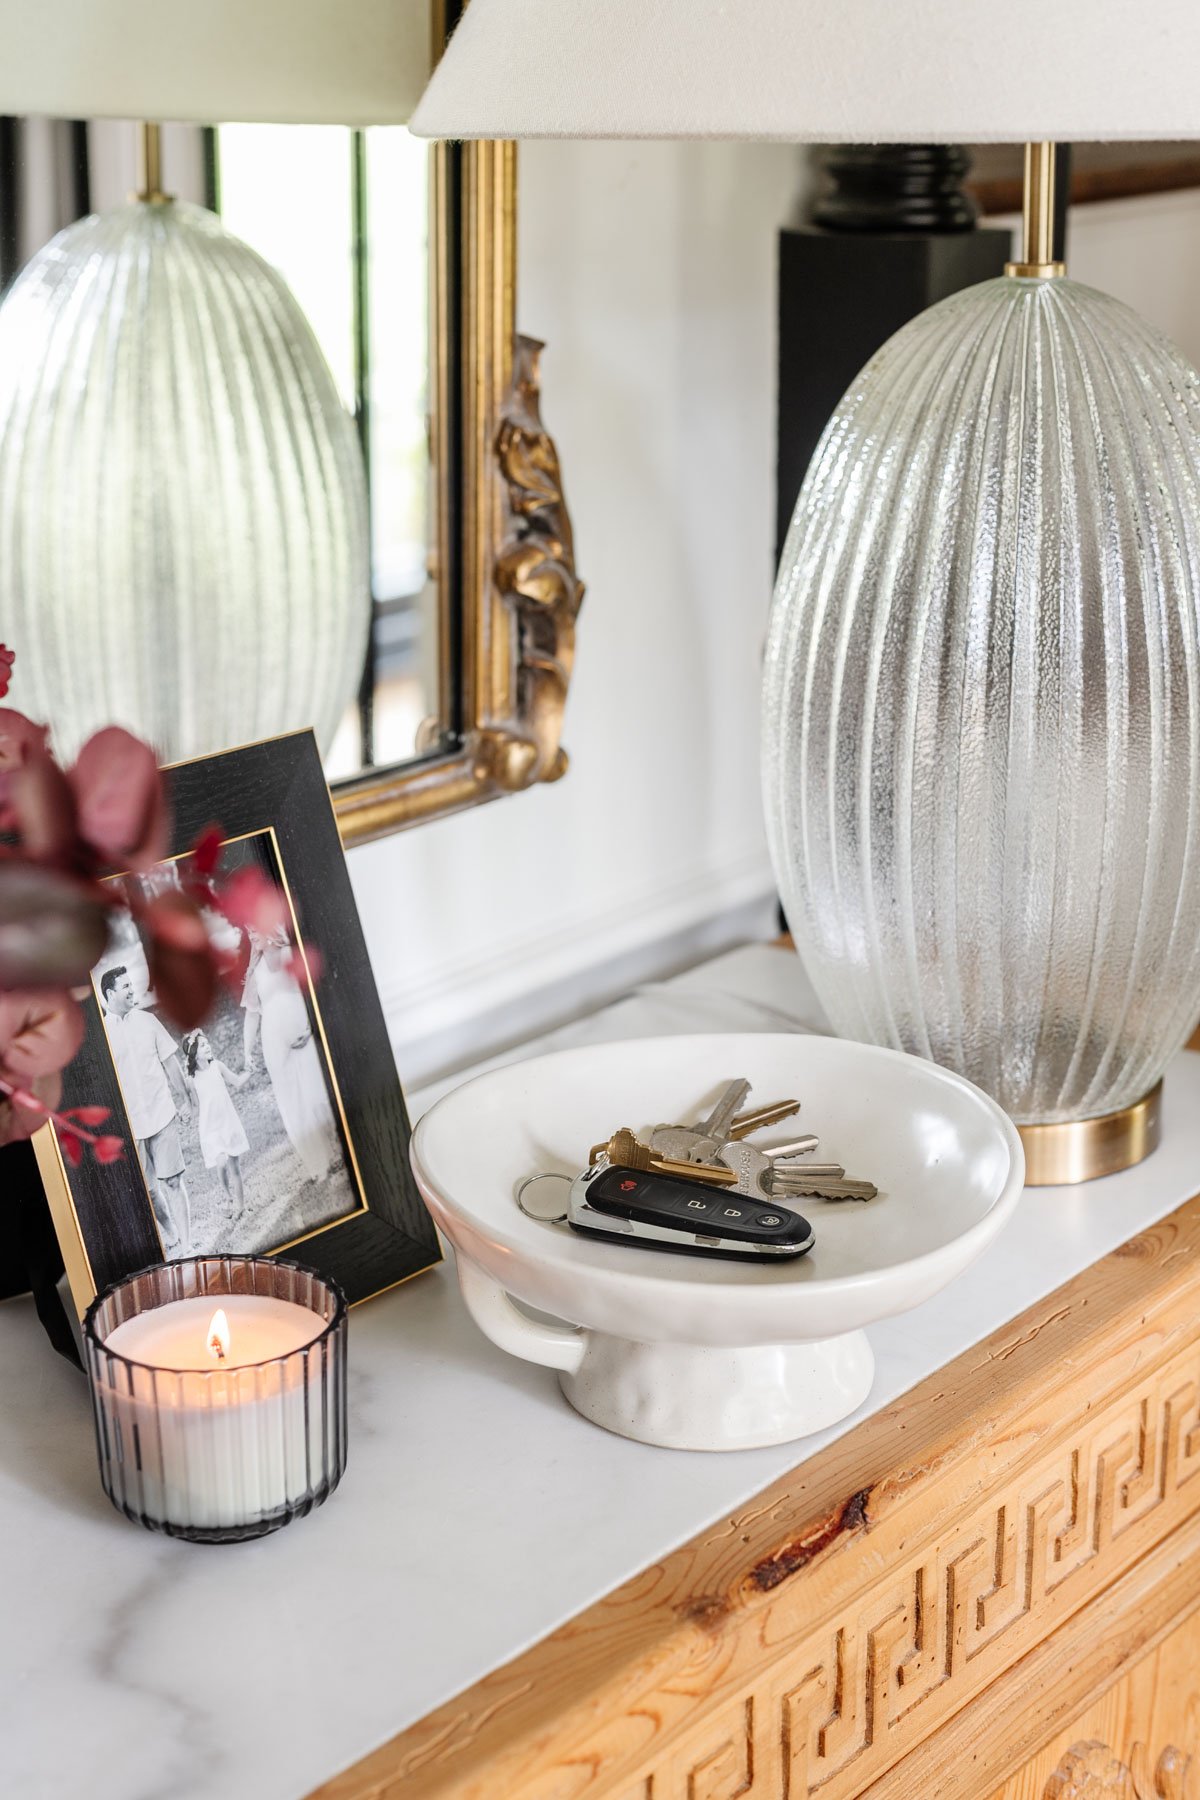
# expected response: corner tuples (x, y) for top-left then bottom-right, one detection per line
(763, 277), (1200, 1123)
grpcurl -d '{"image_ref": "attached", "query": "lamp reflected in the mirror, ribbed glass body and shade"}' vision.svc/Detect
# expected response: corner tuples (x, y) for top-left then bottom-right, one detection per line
(0, 0), (432, 760)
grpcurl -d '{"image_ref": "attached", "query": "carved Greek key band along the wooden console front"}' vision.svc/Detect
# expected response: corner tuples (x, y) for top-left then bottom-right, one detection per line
(630, 1350), (1200, 1800)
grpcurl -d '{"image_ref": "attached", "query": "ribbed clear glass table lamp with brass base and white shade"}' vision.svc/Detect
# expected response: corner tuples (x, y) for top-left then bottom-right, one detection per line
(414, 0), (1200, 1183)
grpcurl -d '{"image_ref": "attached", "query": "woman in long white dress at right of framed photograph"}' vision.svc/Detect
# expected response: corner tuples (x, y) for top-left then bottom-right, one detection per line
(241, 931), (342, 1181)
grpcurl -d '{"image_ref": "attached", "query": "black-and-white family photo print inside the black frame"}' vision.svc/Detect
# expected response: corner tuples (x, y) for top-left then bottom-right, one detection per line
(92, 832), (362, 1258)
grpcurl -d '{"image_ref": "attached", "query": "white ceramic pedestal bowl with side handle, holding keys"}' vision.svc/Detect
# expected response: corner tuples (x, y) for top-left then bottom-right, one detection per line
(412, 1033), (1024, 1451)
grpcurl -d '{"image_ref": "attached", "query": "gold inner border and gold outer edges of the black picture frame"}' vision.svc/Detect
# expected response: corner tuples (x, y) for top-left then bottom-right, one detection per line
(32, 824), (390, 1318)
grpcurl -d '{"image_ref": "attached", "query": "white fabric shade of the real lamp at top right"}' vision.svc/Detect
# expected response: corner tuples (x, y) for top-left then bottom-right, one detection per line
(412, 0), (1200, 144)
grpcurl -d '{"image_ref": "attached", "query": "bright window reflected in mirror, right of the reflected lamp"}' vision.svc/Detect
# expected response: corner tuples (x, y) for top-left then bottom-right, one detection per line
(212, 124), (439, 781)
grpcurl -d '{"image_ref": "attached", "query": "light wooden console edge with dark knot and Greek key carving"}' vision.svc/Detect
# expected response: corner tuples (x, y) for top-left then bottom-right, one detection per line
(320, 1199), (1200, 1800)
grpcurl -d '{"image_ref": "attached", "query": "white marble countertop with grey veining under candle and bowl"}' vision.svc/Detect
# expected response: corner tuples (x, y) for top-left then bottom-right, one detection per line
(0, 947), (1200, 1800)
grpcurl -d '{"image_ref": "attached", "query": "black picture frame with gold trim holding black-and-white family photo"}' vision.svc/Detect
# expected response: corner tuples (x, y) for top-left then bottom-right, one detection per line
(34, 731), (441, 1316)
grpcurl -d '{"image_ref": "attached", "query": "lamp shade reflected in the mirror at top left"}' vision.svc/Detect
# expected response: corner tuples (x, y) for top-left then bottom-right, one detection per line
(0, 0), (432, 124)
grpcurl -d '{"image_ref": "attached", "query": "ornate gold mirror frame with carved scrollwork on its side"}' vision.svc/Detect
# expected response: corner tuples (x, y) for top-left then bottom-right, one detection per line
(335, 144), (583, 844)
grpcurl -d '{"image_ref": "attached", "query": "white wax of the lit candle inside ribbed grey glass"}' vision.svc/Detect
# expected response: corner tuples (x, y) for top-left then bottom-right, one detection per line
(104, 1294), (333, 1530)
